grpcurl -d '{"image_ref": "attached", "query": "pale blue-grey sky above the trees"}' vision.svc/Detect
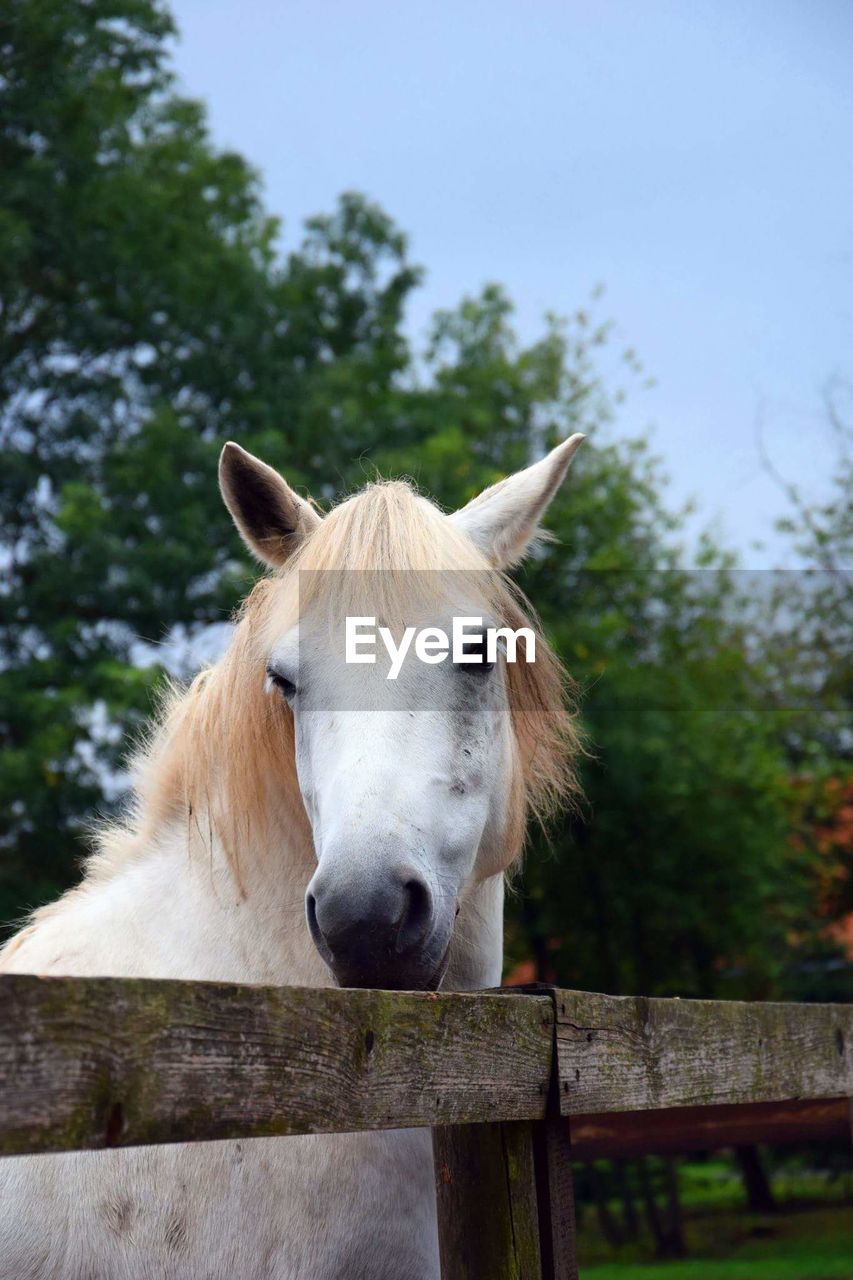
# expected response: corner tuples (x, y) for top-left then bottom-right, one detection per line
(173, 0), (853, 567)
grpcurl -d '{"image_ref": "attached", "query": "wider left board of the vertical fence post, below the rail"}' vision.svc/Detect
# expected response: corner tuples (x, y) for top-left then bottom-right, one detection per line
(433, 1121), (543, 1280)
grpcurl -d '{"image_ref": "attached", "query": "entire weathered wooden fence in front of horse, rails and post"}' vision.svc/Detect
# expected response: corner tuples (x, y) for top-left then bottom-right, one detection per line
(0, 975), (853, 1280)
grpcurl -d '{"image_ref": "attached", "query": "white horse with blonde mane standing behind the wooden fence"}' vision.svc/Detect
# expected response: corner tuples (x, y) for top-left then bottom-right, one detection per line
(0, 435), (581, 1280)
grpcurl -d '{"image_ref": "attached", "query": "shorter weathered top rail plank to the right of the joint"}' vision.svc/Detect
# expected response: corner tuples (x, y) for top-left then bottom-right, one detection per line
(556, 991), (853, 1115)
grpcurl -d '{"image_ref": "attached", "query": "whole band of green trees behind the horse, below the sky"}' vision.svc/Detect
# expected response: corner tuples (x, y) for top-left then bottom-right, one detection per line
(0, 0), (849, 1029)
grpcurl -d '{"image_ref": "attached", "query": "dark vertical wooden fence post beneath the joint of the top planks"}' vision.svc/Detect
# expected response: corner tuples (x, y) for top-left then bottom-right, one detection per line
(433, 986), (578, 1280)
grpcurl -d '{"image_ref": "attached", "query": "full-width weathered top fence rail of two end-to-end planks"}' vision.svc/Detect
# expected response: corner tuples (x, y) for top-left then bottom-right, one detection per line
(0, 974), (853, 1155)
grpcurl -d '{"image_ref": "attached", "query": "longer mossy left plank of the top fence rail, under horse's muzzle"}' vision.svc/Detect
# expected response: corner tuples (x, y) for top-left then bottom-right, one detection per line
(0, 975), (553, 1155)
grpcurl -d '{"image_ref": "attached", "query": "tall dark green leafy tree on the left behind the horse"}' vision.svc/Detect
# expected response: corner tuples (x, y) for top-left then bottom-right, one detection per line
(0, 0), (418, 919)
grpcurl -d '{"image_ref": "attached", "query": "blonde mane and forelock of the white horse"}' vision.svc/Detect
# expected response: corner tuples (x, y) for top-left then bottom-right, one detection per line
(87, 480), (579, 884)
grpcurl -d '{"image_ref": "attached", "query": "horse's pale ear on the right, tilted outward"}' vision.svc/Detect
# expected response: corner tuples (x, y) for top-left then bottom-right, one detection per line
(451, 435), (585, 568)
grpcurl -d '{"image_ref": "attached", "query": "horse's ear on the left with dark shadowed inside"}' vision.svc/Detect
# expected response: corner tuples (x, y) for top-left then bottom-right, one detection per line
(219, 440), (320, 568)
